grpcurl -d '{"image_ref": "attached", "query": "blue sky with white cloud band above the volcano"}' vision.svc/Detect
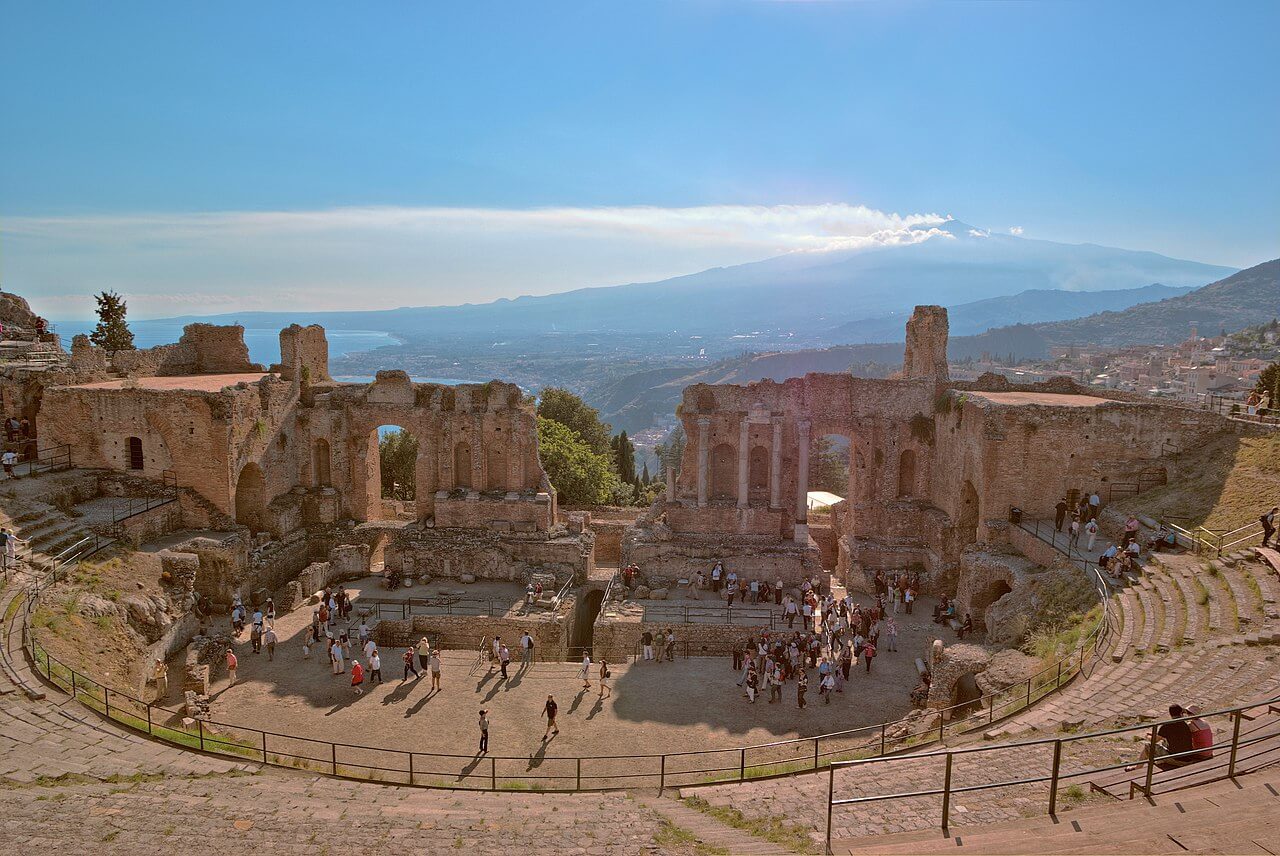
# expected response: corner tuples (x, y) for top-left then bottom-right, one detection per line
(0, 0), (1280, 317)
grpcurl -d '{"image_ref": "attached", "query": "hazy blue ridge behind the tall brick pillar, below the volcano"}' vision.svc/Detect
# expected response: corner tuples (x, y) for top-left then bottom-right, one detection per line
(829, 283), (1193, 343)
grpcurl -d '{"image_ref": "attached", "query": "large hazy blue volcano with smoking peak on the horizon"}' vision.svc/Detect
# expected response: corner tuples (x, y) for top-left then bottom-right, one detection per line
(122, 221), (1233, 347)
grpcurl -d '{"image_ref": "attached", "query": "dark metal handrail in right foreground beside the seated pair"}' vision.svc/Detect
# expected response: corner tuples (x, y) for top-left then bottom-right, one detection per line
(824, 696), (1280, 853)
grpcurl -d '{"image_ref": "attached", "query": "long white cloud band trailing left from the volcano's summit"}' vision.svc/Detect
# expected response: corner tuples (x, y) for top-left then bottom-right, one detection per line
(3, 203), (950, 317)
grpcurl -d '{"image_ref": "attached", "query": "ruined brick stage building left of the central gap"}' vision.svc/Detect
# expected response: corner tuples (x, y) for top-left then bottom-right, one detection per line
(38, 325), (589, 576)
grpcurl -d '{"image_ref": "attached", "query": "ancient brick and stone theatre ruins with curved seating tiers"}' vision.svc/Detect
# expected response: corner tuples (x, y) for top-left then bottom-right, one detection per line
(0, 291), (1280, 855)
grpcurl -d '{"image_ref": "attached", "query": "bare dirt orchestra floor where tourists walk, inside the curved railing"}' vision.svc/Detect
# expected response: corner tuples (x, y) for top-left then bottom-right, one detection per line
(186, 588), (941, 756)
